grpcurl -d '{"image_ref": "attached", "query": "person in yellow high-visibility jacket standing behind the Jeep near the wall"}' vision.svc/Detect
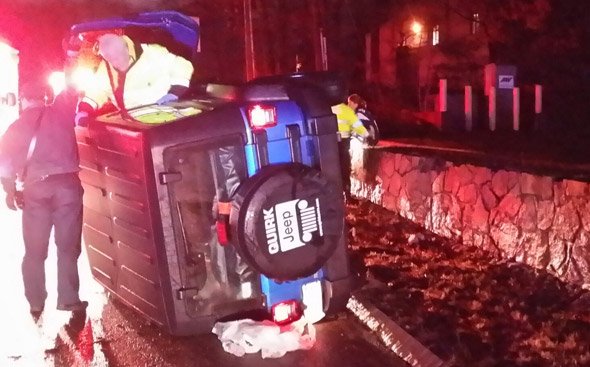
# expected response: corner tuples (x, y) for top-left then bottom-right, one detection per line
(332, 103), (369, 197)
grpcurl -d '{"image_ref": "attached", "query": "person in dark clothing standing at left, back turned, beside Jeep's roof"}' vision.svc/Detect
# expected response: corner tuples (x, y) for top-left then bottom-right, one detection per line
(0, 83), (87, 317)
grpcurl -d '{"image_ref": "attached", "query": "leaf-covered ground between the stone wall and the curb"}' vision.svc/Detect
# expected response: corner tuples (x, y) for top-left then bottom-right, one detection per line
(347, 202), (590, 367)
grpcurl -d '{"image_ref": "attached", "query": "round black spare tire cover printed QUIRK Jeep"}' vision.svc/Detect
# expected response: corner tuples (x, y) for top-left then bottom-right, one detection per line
(230, 163), (344, 281)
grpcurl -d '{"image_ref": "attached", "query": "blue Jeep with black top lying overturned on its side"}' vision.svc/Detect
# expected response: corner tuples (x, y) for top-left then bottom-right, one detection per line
(71, 12), (351, 335)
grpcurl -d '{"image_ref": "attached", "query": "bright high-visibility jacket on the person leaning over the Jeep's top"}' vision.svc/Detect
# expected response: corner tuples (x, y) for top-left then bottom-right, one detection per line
(82, 39), (193, 109)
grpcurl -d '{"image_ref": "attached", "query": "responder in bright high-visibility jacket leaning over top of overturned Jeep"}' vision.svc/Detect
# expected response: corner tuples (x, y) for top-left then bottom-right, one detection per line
(76, 34), (194, 123)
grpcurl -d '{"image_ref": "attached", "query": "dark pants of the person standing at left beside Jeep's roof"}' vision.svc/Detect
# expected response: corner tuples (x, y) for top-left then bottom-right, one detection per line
(22, 174), (83, 307)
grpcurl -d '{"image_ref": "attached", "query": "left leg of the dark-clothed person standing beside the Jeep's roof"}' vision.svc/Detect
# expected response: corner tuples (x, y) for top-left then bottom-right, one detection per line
(22, 184), (52, 312)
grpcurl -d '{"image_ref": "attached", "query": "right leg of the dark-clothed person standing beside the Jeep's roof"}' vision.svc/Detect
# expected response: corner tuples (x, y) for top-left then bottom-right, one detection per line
(52, 175), (83, 310)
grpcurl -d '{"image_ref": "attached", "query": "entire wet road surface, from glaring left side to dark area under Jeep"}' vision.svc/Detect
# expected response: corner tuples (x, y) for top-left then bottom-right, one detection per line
(0, 206), (405, 367)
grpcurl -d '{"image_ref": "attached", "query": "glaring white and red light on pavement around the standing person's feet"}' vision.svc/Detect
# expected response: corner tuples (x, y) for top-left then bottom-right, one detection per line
(0, 206), (108, 367)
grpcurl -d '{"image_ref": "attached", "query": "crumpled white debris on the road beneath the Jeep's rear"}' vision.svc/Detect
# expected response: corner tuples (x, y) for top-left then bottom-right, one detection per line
(212, 317), (316, 358)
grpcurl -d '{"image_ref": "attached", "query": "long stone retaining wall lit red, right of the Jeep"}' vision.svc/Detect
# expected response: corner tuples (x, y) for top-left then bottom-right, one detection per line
(352, 145), (590, 288)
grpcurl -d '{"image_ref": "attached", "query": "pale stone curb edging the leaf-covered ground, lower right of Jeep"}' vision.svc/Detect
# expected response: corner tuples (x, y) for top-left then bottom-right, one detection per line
(346, 292), (449, 367)
